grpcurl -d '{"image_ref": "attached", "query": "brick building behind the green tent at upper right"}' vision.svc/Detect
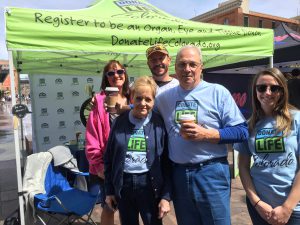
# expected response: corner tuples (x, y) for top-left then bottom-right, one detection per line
(191, 0), (300, 32)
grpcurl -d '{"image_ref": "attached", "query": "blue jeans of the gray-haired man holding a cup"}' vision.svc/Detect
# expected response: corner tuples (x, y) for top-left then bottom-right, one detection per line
(172, 158), (231, 225)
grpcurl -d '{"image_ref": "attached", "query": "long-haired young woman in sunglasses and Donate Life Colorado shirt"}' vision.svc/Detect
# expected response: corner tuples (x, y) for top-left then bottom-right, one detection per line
(234, 68), (300, 225)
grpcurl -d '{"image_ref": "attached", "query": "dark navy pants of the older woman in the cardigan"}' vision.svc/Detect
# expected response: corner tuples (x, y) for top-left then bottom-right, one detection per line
(118, 173), (162, 225)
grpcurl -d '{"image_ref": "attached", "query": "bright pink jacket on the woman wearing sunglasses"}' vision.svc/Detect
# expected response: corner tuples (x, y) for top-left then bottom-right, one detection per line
(85, 93), (110, 175)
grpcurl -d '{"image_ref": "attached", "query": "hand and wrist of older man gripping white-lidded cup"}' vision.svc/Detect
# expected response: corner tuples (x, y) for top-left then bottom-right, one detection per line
(180, 122), (220, 143)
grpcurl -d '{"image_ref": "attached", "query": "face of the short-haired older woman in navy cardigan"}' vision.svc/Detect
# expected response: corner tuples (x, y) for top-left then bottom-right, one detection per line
(132, 86), (155, 119)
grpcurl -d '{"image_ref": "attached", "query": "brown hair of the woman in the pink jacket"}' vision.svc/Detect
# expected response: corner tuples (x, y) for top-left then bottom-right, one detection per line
(101, 60), (130, 98)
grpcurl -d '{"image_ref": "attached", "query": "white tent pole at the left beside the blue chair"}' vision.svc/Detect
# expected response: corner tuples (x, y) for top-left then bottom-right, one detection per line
(8, 51), (25, 225)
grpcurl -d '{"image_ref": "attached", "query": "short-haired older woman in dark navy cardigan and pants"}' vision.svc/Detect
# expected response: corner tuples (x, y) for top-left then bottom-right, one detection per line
(104, 76), (171, 225)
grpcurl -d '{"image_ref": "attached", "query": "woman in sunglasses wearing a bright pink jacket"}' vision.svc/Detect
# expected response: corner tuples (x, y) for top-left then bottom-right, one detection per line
(85, 60), (130, 225)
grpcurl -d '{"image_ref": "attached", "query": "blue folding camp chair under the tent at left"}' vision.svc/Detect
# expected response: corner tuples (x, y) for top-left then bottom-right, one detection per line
(34, 163), (98, 225)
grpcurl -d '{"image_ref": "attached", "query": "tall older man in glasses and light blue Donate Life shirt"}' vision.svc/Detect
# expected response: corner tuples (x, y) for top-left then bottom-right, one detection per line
(155, 46), (248, 225)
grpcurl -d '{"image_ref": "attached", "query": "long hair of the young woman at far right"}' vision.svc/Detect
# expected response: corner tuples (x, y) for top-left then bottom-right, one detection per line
(249, 68), (295, 136)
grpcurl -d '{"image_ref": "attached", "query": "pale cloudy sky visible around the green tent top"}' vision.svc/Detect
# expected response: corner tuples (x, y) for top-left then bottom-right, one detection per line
(0, 0), (300, 59)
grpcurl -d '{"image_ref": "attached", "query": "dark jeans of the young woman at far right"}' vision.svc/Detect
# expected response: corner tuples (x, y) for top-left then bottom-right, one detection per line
(246, 197), (300, 225)
